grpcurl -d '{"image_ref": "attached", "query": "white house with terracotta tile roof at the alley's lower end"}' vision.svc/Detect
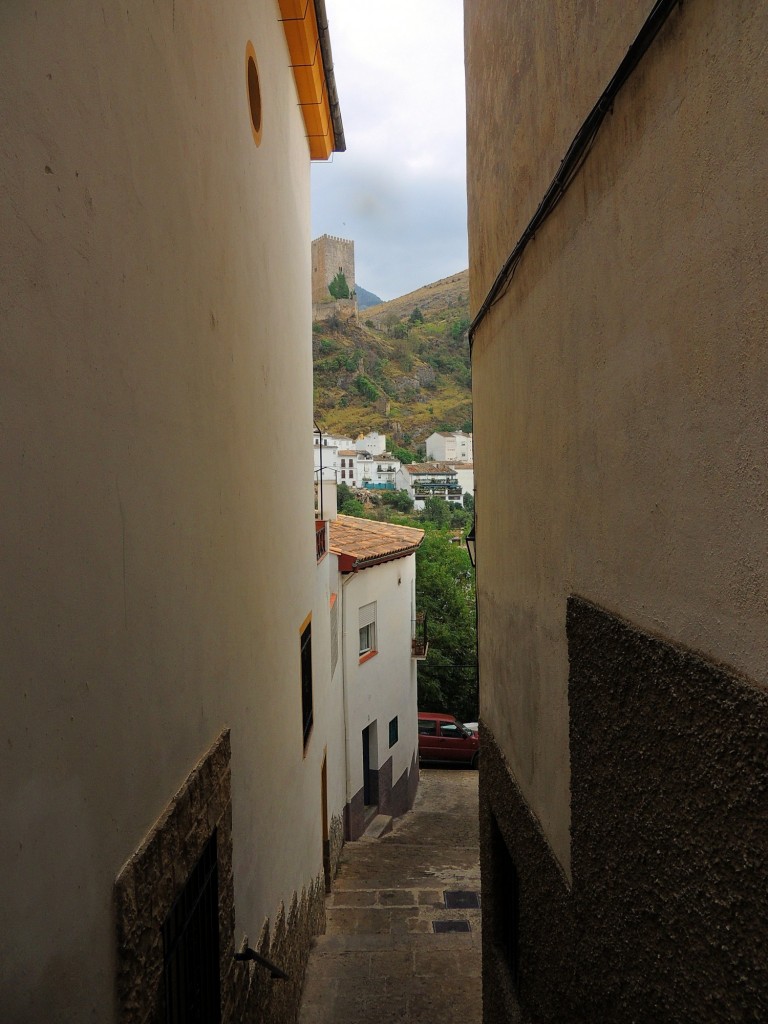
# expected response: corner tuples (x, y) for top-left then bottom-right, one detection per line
(329, 515), (425, 840)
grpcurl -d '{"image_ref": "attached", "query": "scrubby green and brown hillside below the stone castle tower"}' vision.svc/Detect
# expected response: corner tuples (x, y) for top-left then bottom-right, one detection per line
(312, 270), (472, 449)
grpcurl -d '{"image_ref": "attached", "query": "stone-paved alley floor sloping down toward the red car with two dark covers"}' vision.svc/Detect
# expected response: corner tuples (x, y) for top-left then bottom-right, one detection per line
(300, 769), (481, 1024)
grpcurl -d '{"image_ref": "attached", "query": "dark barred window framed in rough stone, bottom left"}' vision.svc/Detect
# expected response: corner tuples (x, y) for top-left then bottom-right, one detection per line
(163, 829), (221, 1024)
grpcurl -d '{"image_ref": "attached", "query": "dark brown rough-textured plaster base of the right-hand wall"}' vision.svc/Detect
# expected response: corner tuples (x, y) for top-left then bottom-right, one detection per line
(480, 598), (768, 1024)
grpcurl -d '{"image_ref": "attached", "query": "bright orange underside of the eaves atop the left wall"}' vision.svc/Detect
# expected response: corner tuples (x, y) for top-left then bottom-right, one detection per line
(279, 0), (335, 160)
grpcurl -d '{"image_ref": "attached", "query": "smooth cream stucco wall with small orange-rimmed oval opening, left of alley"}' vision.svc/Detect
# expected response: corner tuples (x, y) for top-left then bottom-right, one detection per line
(0, 0), (331, 1022)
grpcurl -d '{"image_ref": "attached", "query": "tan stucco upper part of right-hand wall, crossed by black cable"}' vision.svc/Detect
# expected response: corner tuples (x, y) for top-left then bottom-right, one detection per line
(465, 0), (768, 871)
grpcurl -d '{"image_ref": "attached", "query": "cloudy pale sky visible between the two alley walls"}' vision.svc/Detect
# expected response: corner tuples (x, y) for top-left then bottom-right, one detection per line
(312, 0), (467, 299)
